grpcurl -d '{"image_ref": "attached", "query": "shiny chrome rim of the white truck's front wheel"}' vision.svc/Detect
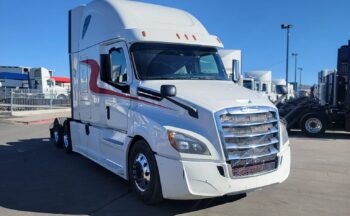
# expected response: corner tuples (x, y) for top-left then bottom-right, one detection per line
(132, 153), (151, 192)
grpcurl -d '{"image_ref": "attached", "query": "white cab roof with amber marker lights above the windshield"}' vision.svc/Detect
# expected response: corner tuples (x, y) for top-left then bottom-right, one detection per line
(69, 0), (223, 53)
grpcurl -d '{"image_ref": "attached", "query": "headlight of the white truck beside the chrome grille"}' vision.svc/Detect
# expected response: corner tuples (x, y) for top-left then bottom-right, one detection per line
(168, 131), (210, 155)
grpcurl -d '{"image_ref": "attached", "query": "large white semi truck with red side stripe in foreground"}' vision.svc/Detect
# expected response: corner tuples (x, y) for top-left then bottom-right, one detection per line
(50, 0), (290, 203)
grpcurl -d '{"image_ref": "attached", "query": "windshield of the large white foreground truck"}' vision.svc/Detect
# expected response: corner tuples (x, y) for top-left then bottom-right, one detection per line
(131, 43), (228, 80)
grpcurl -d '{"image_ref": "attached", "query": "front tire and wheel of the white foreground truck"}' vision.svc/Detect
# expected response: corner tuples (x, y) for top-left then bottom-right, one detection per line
(128, 140), (163, 205)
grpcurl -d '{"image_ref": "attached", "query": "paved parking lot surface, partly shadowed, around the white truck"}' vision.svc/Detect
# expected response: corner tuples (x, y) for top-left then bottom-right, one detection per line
(0, 120), (350, 216)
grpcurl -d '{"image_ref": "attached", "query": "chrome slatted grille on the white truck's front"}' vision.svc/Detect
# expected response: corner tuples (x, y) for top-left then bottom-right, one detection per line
(216, 106), (280, 177)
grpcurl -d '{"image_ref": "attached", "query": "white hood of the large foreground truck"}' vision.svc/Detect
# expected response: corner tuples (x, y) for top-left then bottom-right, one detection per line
(140, 80), (275, 112)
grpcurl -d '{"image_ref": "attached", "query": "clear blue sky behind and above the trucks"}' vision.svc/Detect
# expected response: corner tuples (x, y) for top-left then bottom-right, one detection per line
(0, 0), (350, 84)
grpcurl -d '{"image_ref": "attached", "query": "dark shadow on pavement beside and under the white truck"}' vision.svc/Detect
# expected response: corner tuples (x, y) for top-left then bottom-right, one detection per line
(0, 139), (245, 215)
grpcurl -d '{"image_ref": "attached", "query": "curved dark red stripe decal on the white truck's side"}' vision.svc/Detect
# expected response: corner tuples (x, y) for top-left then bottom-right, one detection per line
(81, 59), (170, 109)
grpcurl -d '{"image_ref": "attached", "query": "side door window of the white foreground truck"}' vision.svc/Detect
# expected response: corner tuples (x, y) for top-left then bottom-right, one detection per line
(109, 48), (128, 84)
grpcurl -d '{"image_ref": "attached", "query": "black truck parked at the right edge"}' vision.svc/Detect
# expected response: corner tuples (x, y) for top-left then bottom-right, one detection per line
(279, 42), (350, 136)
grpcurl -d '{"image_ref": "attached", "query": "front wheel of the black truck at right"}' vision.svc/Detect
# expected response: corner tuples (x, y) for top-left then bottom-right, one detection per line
(301, 114), (326, 137)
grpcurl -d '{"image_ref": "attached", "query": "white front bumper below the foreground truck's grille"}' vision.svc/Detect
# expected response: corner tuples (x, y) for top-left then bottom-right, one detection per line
(156, 146), (290, 200)
